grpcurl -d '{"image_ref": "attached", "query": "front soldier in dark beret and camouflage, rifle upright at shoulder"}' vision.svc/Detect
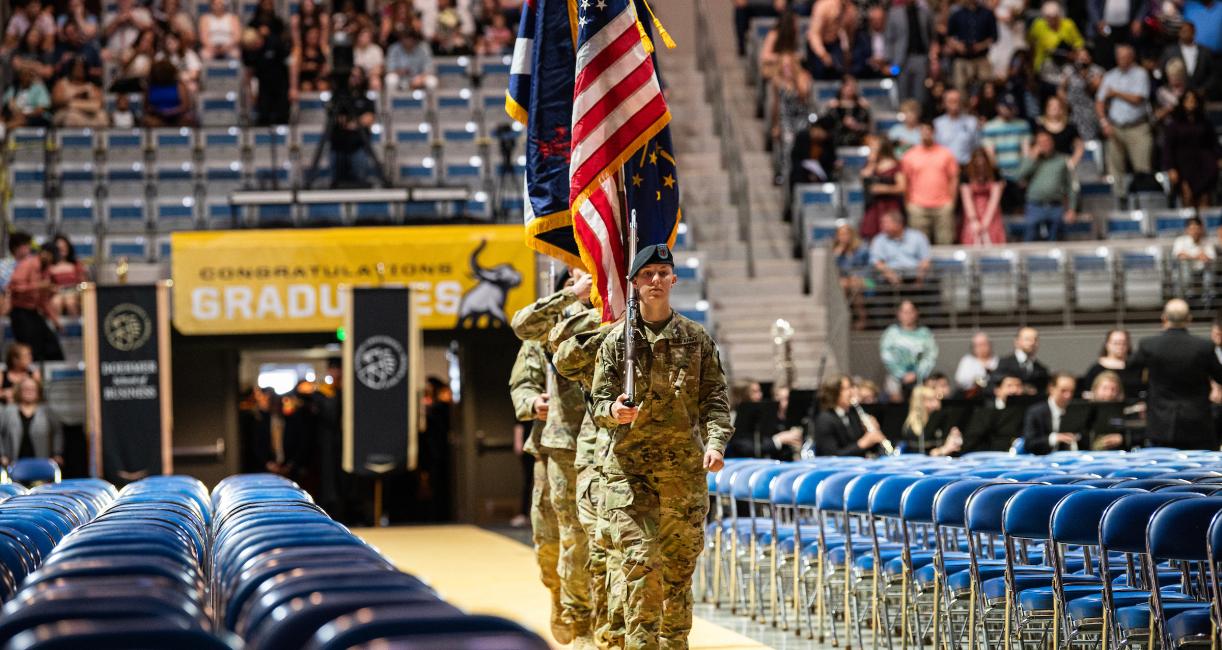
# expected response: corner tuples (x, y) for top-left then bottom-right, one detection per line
(593, 244), (733, 649)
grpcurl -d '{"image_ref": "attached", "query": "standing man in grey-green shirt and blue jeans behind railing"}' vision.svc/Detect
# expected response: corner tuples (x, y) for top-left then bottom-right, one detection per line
(1018, 131), (1078, 242)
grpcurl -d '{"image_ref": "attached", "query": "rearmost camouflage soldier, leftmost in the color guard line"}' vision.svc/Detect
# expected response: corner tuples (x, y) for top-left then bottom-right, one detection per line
(510, 341), (572, 643)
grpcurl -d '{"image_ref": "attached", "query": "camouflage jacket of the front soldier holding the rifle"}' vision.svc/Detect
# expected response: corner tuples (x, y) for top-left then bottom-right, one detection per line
(593, 312), (733, 475)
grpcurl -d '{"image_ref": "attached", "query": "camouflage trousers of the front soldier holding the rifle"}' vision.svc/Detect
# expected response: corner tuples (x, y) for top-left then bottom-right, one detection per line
(602, 473), (709, 649)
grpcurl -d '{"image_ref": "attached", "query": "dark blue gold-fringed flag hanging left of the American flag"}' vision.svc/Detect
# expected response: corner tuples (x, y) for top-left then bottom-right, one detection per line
(506, 0), (582, 266)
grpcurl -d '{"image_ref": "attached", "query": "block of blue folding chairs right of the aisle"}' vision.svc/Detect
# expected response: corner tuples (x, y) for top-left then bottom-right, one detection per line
(697, 448), (1222, 649)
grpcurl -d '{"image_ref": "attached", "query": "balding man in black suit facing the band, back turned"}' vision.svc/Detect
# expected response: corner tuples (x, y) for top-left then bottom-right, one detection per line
(1133, 298), (1222, 450)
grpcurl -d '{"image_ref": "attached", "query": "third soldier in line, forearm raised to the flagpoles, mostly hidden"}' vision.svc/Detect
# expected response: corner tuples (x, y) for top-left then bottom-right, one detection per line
(511, 269), (594, 645)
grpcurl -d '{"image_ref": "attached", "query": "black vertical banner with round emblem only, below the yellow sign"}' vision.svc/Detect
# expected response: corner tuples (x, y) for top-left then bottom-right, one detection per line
(343, 287), (420, 475)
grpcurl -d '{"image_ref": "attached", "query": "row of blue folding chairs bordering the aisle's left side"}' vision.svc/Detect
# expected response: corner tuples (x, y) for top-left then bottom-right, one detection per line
(211, 474), (547, 650)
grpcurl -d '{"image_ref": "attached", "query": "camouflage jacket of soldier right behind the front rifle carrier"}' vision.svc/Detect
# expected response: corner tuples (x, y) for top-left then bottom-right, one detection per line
(547, 309), (611, 467)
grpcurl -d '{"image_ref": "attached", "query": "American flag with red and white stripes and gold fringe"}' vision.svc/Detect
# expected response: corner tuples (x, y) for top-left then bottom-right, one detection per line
(568, 0), (671, 321)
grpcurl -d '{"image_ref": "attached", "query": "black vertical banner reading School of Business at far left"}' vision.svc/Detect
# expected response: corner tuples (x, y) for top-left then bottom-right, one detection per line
(84, 283), (172, 485)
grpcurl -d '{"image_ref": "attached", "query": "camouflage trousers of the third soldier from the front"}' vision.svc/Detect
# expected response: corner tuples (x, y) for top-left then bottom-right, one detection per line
(547, 447), (593, 637)
